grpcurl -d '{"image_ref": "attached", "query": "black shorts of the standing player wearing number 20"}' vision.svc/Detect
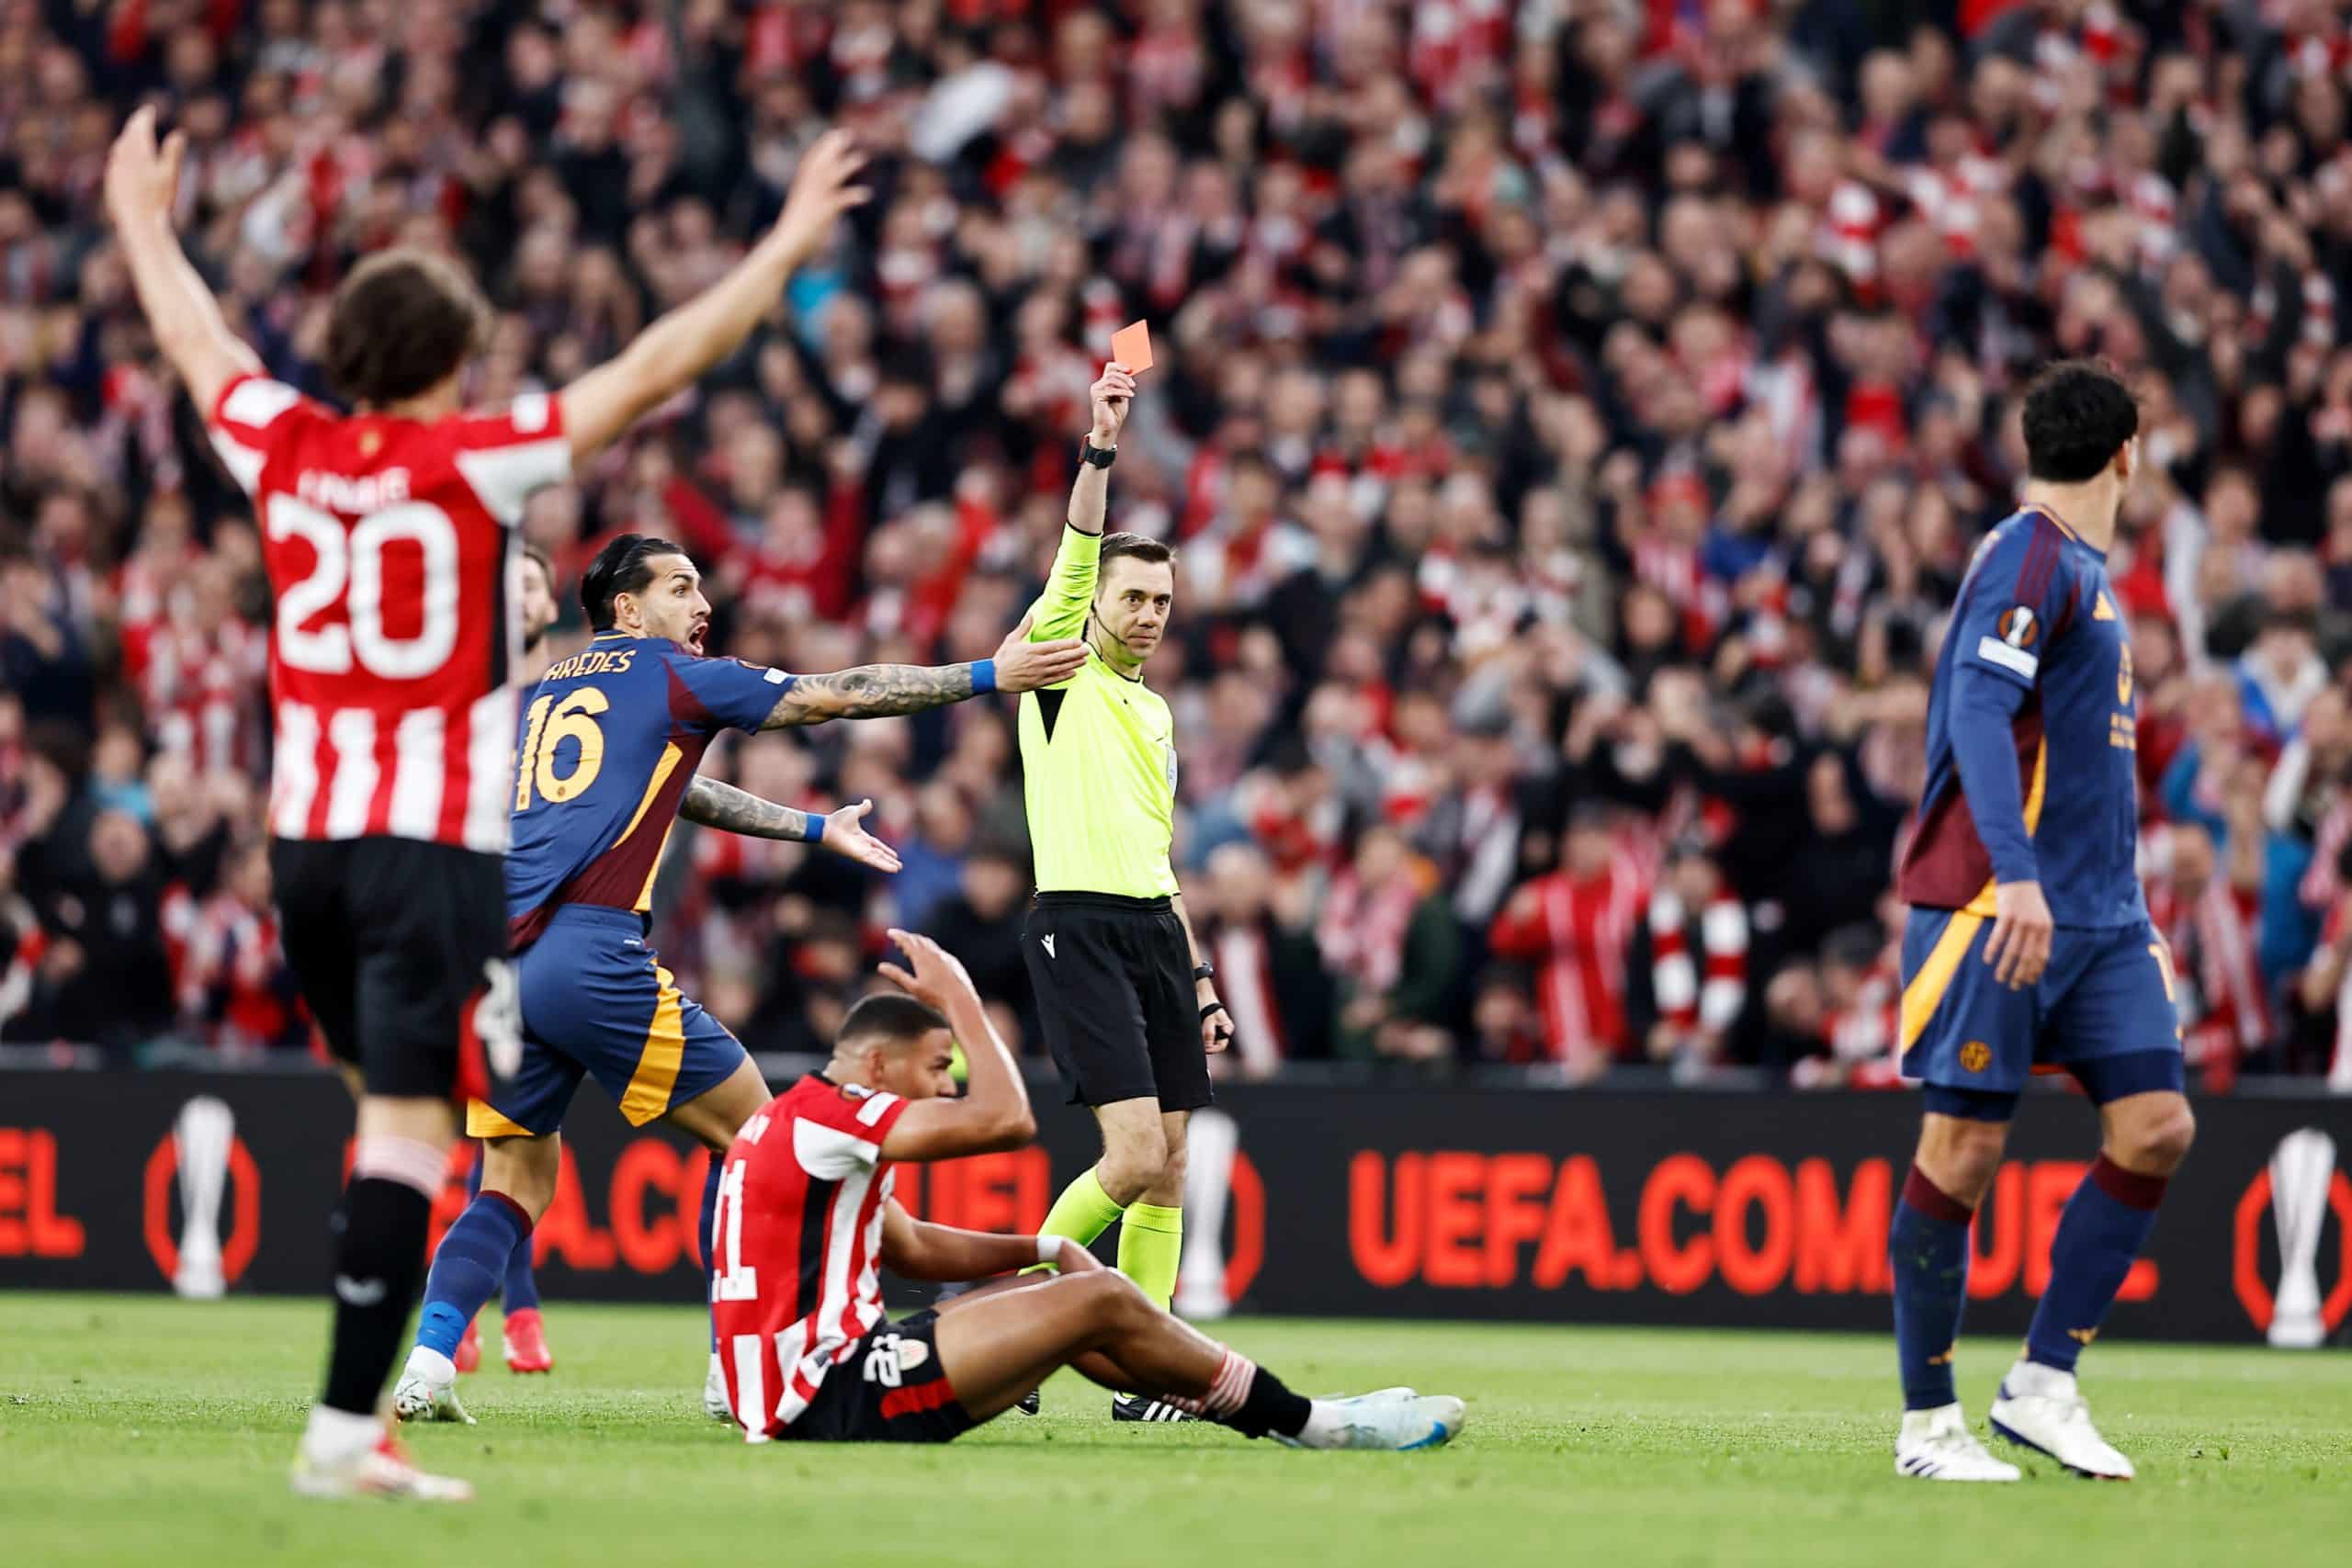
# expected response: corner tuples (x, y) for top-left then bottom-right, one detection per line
(270, 837), (522, 1100)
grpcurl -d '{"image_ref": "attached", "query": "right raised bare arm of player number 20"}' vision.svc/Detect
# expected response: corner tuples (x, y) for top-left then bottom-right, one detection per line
(562, 131), (868, 463)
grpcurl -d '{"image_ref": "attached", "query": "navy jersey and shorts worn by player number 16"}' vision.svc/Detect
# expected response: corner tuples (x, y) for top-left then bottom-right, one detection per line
(466, 632), (793, 1138)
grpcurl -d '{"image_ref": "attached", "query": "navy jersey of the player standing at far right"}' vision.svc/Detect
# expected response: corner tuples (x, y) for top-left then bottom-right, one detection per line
(1898, 508), (2147, 929)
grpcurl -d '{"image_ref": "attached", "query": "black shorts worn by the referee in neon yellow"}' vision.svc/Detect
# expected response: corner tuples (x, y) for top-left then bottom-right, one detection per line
(1021, 894), (1214, 1110)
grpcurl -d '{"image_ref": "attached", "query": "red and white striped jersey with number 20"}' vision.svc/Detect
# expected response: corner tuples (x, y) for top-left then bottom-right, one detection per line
(211, 376), (571, 853)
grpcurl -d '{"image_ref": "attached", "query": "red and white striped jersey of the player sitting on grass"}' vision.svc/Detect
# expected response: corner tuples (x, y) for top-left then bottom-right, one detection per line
(710, 1072), (908, 1443)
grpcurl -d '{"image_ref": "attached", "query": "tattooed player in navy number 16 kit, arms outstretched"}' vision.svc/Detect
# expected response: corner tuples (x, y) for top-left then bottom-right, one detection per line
(393, 534), (1084, 1420)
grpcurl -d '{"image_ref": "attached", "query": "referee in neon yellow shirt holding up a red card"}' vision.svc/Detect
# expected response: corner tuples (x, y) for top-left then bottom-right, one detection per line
(1021, 365), (1232, 1420)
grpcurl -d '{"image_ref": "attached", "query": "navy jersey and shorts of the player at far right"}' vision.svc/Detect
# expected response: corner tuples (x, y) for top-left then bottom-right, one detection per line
(1898, 508), (2183, 1119)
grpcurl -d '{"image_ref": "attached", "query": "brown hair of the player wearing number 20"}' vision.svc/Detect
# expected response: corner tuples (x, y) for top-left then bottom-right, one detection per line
(327, 249), (492, 409)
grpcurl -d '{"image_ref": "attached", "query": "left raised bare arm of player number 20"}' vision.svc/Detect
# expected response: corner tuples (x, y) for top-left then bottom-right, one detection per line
(106, 108), (261, 419)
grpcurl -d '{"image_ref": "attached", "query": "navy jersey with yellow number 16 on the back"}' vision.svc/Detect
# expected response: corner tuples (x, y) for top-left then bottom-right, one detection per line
(505, 632), (793, 952)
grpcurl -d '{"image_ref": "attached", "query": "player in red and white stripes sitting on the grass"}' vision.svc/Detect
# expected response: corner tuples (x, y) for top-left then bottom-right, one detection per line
(713, 931), (1463, 1448)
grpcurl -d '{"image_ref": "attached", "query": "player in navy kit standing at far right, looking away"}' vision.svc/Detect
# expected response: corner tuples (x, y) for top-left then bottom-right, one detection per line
(1889, 362), (2197, 1481)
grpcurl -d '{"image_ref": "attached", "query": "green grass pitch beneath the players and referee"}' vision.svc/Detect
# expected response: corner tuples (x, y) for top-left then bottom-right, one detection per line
(0, 1295), (2352, 1568)
